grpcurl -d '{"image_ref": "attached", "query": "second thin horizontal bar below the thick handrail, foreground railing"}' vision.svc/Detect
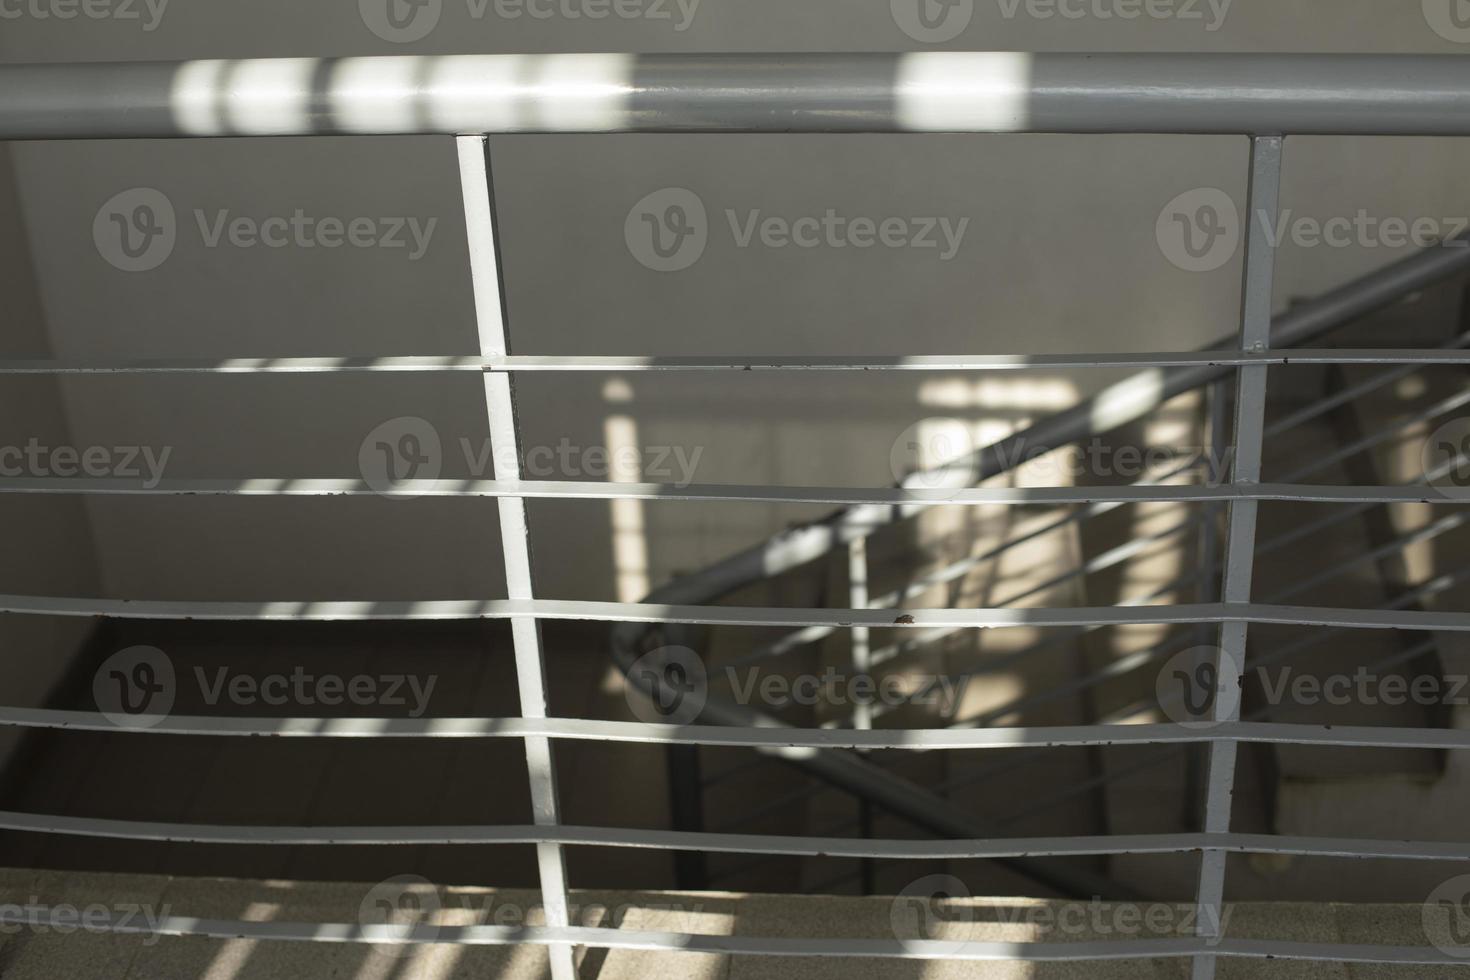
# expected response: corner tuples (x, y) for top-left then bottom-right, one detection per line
(0, 481), (1470, 507)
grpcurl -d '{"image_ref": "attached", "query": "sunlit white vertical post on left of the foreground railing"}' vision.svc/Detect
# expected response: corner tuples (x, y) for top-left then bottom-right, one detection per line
(456, 137), (576, 980)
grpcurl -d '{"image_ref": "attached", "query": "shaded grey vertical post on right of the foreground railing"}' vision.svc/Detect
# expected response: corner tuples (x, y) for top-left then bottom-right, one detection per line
(1192, 137), (1283, 980)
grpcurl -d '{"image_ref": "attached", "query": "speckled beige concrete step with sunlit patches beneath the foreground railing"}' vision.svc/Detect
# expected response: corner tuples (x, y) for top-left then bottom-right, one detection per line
(0, 870), (1463, 980)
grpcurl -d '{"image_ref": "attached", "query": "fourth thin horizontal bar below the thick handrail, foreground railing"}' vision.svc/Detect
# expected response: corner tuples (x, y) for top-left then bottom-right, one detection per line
(0, 708), (1470, 752)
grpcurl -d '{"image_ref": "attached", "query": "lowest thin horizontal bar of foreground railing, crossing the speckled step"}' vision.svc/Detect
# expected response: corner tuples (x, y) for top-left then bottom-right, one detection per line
(0, 905), (1464, 965)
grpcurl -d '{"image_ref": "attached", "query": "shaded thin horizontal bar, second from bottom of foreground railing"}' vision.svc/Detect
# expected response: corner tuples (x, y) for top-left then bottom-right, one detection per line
(0, 811), (1470, 861)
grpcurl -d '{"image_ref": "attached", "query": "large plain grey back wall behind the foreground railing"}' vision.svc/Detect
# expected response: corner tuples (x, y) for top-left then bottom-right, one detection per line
(0, 0), (1470, 608)
